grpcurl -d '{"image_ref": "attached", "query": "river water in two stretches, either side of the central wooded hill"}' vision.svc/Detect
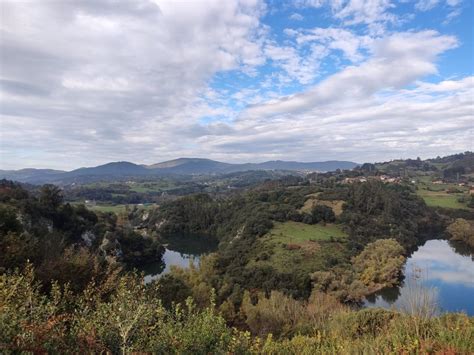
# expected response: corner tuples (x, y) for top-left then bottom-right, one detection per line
(142, 237), (474, 316)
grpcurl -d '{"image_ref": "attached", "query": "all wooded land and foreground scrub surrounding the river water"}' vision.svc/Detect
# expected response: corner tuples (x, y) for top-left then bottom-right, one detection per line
(0, 164), (474, 354)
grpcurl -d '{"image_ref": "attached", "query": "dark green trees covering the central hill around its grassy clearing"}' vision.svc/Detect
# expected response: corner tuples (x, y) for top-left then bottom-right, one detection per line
(139, 181), (442, 308)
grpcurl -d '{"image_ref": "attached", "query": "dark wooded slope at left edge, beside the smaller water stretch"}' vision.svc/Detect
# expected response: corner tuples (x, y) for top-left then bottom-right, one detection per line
(0, 181), (164, 289)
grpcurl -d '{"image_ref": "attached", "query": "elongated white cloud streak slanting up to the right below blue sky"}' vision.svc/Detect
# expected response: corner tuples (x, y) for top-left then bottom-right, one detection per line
(243, 31), (457, 116)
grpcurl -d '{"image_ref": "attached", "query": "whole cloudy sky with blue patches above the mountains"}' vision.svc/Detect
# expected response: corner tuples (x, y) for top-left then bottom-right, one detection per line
(0, 0), (474, 169)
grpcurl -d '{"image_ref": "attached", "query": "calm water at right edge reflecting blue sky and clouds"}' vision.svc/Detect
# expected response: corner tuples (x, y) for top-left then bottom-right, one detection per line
(365, 240), (474, 316)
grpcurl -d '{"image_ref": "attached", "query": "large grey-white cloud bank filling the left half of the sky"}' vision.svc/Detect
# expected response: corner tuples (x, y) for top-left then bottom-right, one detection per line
(1, 0), (265, 167)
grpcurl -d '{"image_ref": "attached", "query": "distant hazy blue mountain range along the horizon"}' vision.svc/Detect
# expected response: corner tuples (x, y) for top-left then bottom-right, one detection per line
(0, 158), (358, 184)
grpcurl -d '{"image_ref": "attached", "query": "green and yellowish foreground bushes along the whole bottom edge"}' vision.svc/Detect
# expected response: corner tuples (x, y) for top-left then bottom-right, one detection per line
(0, 265), (474, 354)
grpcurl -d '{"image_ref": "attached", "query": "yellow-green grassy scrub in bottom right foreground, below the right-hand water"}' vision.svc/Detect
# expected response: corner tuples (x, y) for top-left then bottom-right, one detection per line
(256, 309), (474, 354)
